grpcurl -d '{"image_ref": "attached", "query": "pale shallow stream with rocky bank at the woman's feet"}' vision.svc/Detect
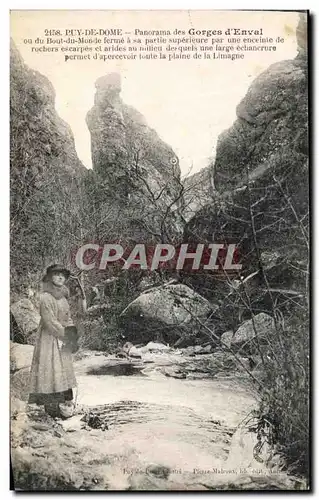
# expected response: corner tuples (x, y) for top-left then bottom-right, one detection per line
(11, 350), (304, 491)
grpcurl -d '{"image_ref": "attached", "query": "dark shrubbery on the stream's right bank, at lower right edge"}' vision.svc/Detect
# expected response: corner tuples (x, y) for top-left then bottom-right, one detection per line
(258, 313), (309, 476)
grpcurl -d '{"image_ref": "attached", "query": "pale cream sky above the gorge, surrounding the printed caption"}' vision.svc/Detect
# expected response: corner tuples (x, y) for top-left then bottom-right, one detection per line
(11, 10), (298, 175)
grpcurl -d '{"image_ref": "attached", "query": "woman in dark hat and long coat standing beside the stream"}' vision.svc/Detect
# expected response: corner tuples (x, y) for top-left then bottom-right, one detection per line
(29, 264), (86, 418)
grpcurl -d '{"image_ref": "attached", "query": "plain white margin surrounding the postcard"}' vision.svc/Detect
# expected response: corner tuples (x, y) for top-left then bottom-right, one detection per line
(0, 0), (319, 499)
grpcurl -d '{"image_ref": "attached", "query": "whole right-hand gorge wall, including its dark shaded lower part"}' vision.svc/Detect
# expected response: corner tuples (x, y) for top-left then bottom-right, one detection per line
(184, 14), (309, 326)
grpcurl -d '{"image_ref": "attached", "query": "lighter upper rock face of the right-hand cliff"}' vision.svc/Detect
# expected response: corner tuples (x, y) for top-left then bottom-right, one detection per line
(213, 57), (308, 195)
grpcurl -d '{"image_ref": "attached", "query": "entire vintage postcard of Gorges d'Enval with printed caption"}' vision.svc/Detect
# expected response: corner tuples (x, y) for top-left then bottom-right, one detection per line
(10, 10), (311, 492)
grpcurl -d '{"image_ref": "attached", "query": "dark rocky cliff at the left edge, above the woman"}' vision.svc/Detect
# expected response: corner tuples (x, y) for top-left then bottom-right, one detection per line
(10, 43), (86, 289)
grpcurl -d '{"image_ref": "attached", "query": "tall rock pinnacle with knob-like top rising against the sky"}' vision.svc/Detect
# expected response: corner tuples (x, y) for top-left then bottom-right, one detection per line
(87, 73), (182, 241)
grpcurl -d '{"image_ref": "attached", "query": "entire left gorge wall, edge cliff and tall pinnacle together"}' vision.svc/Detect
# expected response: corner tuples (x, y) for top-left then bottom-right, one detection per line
(10, 42), (186, 295)
